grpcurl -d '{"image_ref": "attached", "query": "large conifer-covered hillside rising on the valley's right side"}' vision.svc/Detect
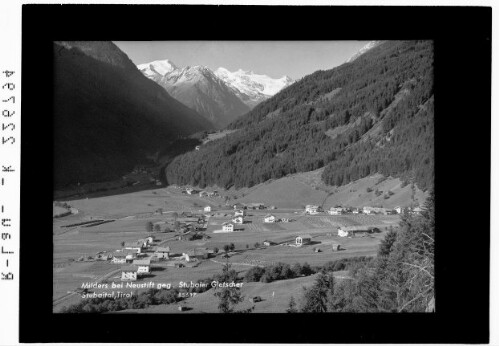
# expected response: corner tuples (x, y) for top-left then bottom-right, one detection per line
(166, 41), (434, 190)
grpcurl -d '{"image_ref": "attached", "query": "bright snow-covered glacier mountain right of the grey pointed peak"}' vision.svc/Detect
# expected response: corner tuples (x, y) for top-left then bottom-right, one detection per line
(215, 67), (293, 108)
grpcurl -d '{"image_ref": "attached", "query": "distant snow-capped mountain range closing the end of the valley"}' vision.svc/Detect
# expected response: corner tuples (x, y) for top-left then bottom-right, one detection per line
(137, 60), (293, 128)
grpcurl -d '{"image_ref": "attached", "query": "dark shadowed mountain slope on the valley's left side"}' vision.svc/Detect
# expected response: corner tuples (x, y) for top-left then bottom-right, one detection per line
(53, 41), (211, 188)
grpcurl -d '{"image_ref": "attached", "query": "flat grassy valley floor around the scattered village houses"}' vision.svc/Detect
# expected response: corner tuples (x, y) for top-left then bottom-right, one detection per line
(53, 172), (412, 311)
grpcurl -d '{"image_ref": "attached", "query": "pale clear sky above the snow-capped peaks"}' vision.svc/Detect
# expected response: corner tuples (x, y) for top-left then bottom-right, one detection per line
(114, 41), (368, 79)
